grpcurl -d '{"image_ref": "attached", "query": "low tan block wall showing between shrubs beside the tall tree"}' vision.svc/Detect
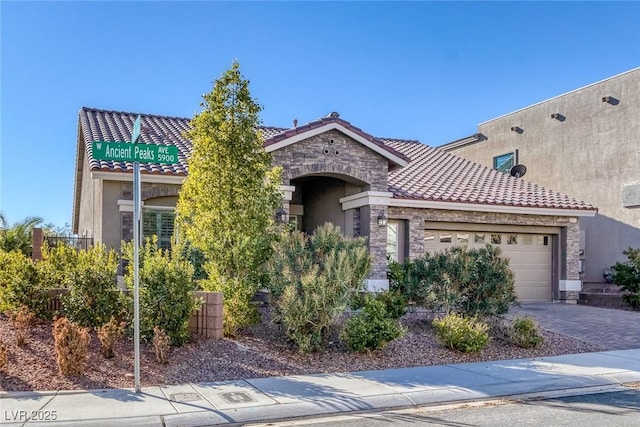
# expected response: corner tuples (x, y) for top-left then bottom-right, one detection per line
(42, 288), (224, 339)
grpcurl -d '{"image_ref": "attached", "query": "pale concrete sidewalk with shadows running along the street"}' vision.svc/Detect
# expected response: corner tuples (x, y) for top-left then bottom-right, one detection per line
(0, 350), (640, 426)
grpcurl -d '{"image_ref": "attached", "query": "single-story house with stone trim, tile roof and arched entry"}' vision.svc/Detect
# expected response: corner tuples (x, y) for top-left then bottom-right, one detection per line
(73, 108), (596, 301)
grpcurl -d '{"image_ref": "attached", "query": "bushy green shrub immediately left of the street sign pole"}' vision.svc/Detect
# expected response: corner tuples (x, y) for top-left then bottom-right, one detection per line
(60, 245), (124, 328)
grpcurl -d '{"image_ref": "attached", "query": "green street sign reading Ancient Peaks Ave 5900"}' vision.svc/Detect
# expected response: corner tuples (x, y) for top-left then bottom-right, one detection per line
(91, 141), (179, 163)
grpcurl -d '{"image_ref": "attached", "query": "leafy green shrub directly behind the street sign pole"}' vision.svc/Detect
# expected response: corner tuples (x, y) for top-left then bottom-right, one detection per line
(122, 236), (199, 346)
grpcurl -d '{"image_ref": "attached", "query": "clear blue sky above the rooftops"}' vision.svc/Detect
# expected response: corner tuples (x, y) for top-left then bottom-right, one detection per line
(0, 1), (640, 231)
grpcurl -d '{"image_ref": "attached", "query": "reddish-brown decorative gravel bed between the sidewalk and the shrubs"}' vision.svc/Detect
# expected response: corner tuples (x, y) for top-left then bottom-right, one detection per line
(0, 312), (605, 391)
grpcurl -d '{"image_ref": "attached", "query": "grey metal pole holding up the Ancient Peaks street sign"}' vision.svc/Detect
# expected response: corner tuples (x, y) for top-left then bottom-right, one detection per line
(131, 116), (141, 393)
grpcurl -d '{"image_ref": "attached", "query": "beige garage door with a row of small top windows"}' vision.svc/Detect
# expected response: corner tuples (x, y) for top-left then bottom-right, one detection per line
(425, 230), (552, 302)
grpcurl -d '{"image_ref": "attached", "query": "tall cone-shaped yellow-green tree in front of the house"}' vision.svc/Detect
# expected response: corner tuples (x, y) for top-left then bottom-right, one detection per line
(177, 62), (282, 334)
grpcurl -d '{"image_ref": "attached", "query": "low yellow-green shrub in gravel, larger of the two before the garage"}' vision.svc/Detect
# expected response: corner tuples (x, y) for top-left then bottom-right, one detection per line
(433, 314), (489, 353)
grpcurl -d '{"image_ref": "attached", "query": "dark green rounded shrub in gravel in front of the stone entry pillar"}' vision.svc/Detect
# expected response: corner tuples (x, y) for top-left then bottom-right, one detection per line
(340, 296), (404, 353)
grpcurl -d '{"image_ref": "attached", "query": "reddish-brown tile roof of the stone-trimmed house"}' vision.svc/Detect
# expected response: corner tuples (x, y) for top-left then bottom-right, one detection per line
(76, 107), (595, 210)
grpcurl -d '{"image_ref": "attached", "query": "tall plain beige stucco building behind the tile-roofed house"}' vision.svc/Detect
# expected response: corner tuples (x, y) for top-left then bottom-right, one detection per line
(439, 68), (640, 283)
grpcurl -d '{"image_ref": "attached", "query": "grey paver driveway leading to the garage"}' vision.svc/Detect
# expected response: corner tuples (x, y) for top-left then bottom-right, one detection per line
(509, 302), (640, 350)
